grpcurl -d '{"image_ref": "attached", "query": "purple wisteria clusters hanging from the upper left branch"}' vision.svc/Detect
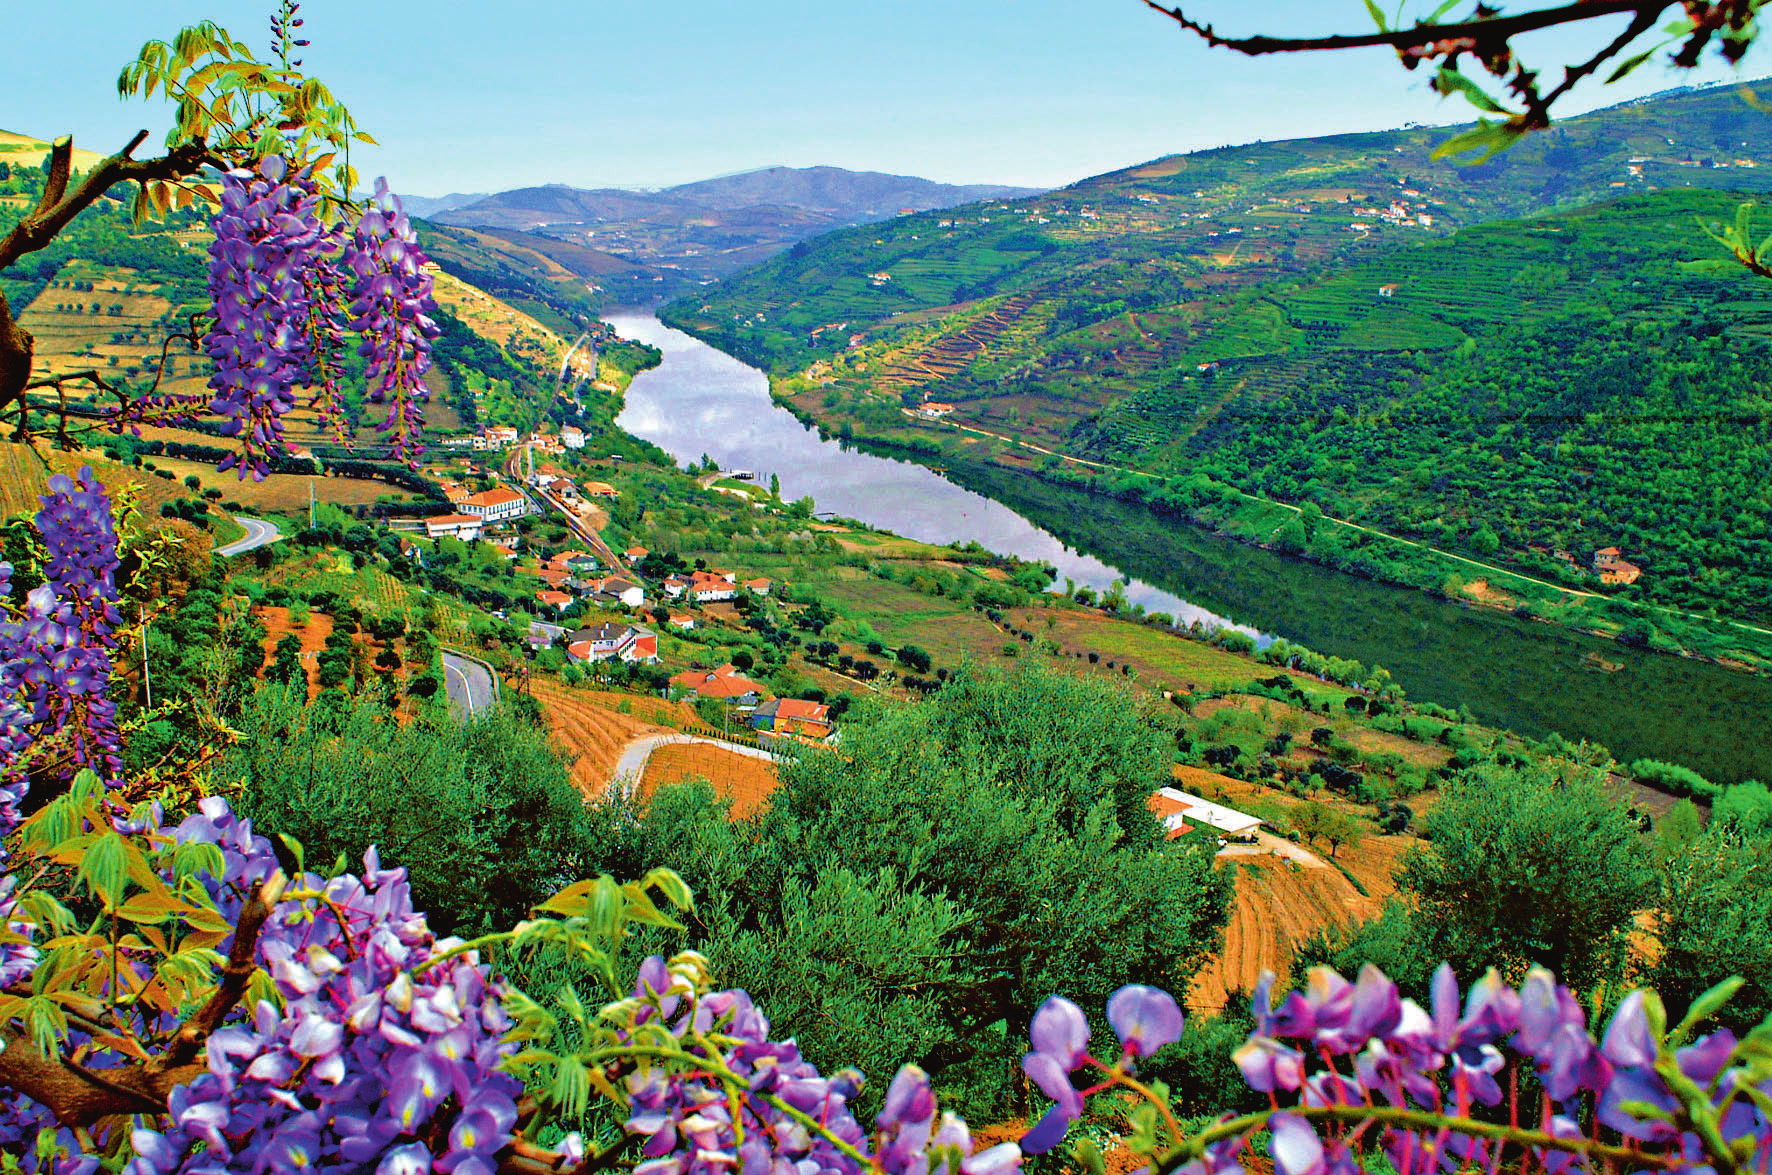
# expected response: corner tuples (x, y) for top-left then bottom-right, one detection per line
(204, 156), (438, 480)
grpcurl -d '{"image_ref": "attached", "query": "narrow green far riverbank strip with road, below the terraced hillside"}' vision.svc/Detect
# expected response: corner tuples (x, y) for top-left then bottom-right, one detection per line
(769, 379), (1772, 673)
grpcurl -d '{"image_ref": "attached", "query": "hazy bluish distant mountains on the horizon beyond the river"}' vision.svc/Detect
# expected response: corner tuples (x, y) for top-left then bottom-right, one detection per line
(402, 167), (1038, 298)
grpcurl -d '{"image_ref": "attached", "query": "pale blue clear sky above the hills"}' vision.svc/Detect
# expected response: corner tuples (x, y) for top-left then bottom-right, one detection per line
(0, 0), (1772, 195)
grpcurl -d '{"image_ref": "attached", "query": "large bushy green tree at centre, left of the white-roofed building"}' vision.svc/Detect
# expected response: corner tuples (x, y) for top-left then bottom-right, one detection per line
(643, 668), (1230, 1111)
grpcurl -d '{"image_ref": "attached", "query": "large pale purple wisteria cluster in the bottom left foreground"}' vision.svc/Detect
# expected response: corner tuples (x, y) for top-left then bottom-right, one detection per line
(126, 798), (521, 1175)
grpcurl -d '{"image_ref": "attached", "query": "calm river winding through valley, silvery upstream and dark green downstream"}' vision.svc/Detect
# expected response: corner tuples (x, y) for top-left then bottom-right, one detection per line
(610, 315), (1772, 782)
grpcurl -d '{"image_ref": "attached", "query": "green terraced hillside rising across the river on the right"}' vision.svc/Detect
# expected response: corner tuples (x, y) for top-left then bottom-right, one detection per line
(666, 90), (1772, 620)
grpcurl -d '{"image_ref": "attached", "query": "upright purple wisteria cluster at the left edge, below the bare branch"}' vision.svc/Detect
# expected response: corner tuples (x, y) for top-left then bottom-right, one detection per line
(0, 468), (122, 801)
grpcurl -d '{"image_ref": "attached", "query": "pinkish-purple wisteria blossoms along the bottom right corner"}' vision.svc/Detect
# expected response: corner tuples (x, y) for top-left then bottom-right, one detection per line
(1063, 966), (1772, 1175)
